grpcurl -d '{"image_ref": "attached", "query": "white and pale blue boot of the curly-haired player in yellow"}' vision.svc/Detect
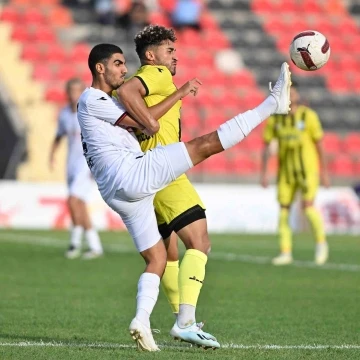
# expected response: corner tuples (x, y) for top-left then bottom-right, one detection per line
(170, 321), (220, 350)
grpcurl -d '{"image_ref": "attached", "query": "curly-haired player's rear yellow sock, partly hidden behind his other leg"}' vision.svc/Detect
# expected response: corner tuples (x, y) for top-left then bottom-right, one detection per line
(161, 260), (179, 314)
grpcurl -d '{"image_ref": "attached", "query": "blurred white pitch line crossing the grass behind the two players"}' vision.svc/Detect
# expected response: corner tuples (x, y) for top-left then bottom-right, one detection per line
(0, 232), (360, 272)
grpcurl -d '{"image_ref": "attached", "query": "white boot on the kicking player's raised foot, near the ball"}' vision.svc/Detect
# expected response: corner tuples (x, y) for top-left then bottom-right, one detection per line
(269, 62), (291, 114)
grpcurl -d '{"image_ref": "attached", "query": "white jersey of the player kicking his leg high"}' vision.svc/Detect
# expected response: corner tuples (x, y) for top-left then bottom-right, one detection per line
(78, 87), (143, 200)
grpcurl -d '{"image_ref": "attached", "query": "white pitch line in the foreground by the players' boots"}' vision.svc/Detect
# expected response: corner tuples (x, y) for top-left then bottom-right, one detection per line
(0, 341), (360, 350)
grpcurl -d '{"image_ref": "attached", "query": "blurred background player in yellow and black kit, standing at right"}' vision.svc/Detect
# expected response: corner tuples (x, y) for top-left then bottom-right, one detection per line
(261, 84), (329, 265)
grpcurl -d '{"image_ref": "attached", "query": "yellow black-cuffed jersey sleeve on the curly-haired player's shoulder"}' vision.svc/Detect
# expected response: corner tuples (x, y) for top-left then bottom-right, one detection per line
(135, 66), (173, 96)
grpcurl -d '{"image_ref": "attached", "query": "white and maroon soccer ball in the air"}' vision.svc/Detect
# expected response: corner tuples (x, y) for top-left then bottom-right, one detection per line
(290, 30), (330, 71)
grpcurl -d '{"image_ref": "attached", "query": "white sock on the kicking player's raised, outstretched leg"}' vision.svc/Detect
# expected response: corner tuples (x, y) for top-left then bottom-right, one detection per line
(217, 95), (277, 150)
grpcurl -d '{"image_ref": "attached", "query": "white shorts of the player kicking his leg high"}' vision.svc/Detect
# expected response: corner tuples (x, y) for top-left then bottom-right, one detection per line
(107, 142), (193, 252)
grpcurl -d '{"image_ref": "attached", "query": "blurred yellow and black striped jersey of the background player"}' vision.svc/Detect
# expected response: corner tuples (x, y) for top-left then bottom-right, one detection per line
(264, 106), (323, 183)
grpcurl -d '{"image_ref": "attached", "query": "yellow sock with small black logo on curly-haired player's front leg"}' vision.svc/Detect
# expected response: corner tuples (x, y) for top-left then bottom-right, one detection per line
(179, 249), (207, 307)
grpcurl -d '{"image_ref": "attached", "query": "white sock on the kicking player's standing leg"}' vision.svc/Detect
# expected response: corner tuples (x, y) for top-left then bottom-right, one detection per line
(136, 273), (160, 327)
